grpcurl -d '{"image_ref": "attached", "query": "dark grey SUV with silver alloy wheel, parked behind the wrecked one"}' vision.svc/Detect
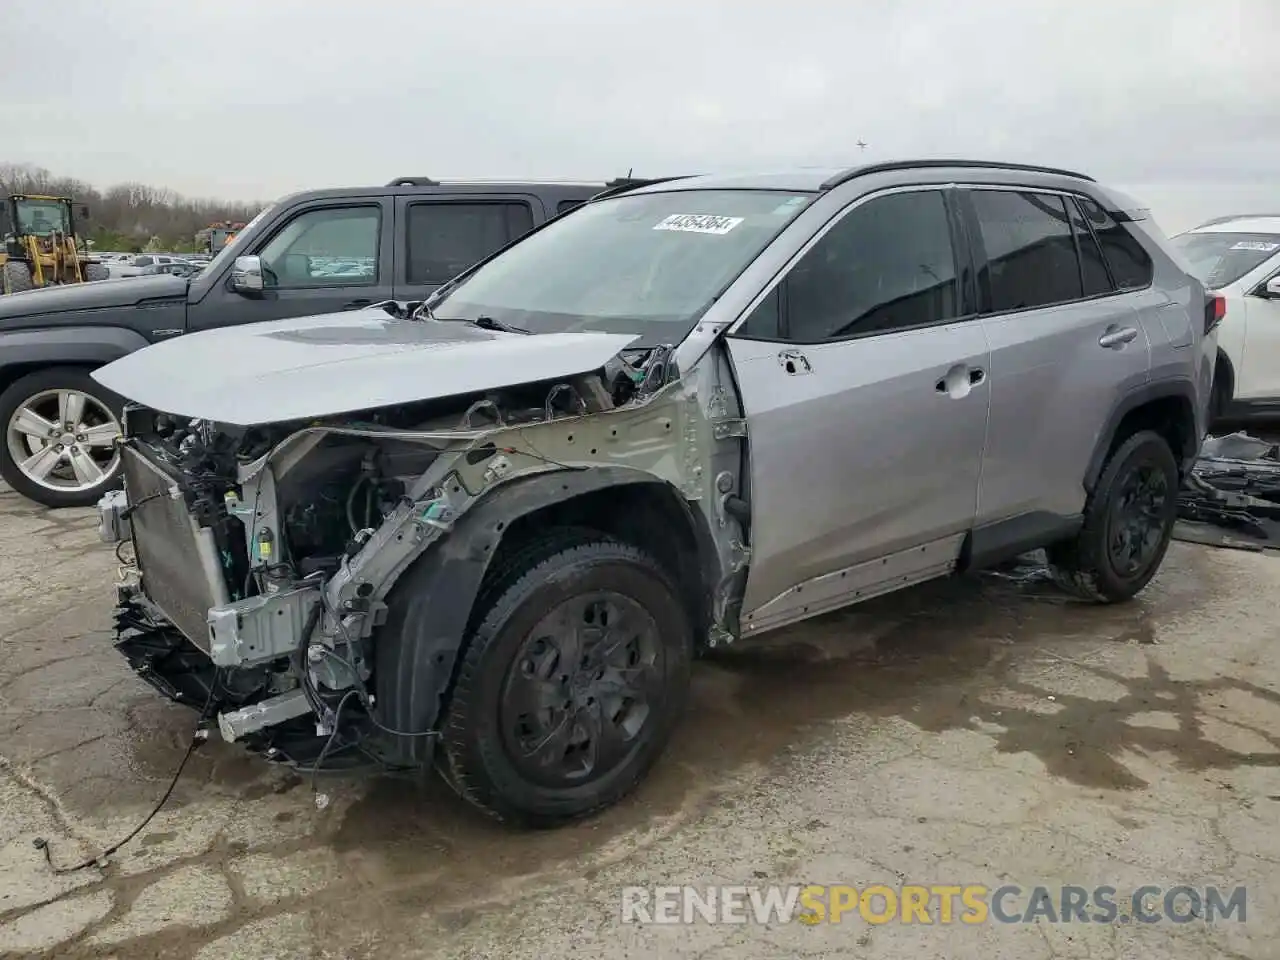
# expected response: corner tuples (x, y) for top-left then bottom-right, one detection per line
(0, 177), (614, 507)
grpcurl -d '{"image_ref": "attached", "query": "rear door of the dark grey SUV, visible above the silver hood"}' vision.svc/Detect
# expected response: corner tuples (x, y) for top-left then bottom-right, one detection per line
(394, 193), (547, 301)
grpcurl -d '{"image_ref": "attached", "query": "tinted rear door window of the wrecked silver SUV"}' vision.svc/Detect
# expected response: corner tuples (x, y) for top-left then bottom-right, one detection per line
(970, 189), (1083, 312)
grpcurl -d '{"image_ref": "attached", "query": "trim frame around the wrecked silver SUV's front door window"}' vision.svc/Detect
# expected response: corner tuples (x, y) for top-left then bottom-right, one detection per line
(724, 183), (979, 347)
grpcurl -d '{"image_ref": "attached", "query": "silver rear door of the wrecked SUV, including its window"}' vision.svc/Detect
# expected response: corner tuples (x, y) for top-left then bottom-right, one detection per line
(964, 186), (1151, 535)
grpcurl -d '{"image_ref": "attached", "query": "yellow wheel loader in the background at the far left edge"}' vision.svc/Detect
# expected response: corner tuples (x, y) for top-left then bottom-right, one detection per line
(0, 195), (108, 293)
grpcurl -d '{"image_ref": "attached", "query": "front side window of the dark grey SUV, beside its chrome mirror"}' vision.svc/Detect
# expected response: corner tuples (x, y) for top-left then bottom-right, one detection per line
(259, 206), (381, 288)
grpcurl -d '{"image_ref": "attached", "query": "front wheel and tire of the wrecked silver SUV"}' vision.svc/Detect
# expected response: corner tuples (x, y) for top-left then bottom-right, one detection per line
(393, 531), (694, 827)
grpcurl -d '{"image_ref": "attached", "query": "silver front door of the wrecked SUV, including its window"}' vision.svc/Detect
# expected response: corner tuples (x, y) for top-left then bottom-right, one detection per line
(727, 188), (988, 634)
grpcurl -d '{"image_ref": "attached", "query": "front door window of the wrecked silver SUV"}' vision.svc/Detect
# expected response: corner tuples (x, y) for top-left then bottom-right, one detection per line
(740, 191), (960, 343)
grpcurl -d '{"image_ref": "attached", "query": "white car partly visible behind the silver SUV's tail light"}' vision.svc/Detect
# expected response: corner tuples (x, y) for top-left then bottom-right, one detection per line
(1172, 214), (1280, 420)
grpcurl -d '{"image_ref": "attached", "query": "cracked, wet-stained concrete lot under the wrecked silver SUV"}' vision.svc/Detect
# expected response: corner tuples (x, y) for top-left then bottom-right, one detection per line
(0, 481), (1280, 960)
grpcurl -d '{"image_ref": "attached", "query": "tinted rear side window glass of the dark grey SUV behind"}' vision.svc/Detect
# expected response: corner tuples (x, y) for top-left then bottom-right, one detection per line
(406, 201), (534, 283)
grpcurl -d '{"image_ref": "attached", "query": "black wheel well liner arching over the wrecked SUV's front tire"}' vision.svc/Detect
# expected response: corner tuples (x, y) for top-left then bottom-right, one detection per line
(374, 467), (716, 764)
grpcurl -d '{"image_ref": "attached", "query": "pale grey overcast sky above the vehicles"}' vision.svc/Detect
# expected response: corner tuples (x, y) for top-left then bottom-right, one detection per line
(0, 0), (1280, 229)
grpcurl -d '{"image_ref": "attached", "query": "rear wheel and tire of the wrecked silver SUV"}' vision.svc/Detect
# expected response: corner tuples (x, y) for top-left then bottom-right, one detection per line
(1046, 430), (1179, 603)
